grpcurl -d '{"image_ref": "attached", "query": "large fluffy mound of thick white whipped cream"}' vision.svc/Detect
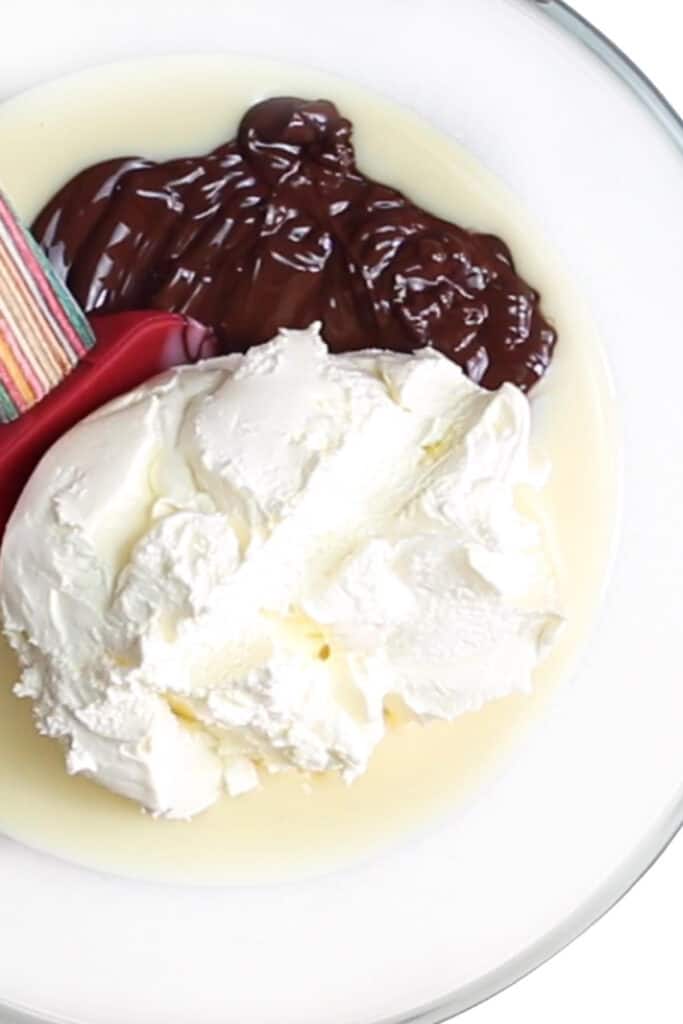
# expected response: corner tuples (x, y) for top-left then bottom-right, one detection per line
(0, 325), (561, 817)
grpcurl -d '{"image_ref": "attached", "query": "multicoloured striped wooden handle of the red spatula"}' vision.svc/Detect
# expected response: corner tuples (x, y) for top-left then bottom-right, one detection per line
(0, 193), (95, 423)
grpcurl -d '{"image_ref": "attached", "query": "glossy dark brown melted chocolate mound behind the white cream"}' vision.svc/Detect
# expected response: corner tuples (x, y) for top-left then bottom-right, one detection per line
(33, 98), (556, 390)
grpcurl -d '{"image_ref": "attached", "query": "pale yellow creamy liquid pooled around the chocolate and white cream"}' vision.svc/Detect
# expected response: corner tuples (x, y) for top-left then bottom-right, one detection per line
(0, 57), (617, 883)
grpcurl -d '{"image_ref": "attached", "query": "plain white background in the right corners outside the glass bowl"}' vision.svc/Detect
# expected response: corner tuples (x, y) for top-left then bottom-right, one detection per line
(466, 0), (683, 1024)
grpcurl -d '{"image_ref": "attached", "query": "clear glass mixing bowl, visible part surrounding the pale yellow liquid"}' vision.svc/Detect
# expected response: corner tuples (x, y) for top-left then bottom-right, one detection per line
(0, 0), (683, 1024)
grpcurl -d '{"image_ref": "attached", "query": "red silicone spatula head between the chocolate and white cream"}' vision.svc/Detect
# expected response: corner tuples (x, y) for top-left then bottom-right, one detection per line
(0, 312), (217, 540)
